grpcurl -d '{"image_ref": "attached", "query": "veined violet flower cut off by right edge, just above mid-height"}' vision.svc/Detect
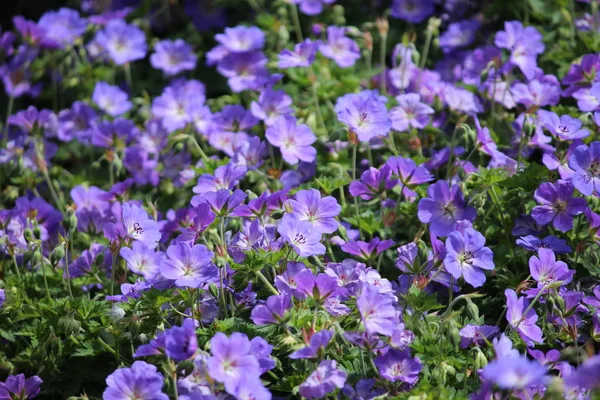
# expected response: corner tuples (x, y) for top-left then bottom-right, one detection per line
(569, 142), (600, 196)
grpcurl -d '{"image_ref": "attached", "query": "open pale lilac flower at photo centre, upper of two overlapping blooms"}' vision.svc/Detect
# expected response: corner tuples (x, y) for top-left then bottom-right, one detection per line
(288, 189), (342, 234)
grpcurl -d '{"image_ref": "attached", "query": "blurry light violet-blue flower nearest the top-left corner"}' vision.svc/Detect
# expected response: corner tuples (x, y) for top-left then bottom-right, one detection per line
(38, 8), (87, 47)
